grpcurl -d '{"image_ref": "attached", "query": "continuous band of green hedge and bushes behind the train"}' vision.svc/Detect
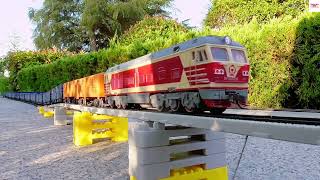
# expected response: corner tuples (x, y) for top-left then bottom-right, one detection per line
(0, 0), (320, 109)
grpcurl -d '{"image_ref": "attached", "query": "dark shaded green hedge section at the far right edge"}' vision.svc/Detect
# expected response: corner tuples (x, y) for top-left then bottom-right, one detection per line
(291, 13), (320, 108)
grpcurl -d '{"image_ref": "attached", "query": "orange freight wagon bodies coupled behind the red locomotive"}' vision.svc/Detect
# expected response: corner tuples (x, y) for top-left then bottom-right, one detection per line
(63, 73), (105, 99)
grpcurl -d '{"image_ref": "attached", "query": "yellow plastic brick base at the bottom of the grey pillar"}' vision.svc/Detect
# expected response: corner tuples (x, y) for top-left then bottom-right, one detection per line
(130, 165), (228, 180)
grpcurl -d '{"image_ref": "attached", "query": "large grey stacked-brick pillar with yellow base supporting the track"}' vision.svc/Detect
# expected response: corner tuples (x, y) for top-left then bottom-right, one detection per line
(129, 120), (228, 180)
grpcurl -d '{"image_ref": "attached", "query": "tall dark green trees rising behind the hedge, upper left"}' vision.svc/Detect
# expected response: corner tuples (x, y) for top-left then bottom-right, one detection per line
(29, 0), (172, 51)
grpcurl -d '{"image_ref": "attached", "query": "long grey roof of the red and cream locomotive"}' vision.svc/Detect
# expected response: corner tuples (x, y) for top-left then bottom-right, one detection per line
(107, 36), (244, 72)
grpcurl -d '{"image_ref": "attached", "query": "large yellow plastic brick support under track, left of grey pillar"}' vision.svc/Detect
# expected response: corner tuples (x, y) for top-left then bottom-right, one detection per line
(73, 112), (128, 146)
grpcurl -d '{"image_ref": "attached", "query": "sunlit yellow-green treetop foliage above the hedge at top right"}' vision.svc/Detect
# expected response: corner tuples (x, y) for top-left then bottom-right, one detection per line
(205, 0), (308, 27)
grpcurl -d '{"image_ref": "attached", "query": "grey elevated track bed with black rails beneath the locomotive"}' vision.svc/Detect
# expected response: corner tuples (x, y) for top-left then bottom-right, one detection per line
(51, 104), (320, 145)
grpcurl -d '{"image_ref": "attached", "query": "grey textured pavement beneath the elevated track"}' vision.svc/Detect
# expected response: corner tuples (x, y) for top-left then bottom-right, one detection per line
(0, 98), (320, 180)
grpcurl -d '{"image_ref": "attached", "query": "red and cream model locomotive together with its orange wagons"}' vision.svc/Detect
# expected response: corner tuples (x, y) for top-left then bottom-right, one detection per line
(4, 36), (250, 113)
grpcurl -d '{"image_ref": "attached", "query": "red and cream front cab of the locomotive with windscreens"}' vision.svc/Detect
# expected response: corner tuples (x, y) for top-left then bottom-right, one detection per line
(189, 38), (249, 111)
